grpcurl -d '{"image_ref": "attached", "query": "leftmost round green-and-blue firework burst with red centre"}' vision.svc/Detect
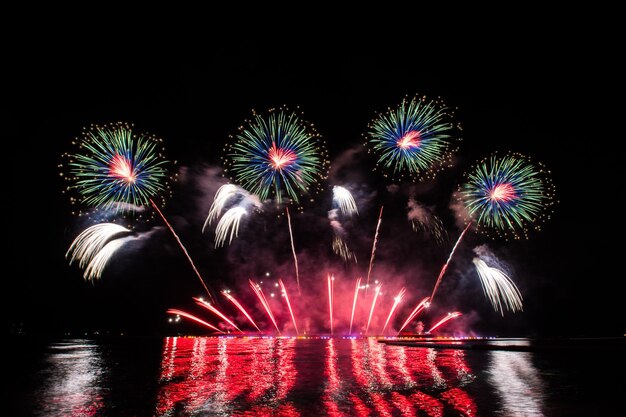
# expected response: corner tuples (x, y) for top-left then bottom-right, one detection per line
(63, 122), (169, 216)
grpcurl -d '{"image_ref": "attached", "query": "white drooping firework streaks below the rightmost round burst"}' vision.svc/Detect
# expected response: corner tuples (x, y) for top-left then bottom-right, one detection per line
(473, 258), (522, 316)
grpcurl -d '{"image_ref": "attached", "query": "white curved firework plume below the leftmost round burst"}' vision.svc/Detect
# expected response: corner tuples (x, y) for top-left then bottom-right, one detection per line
(65, 223), (134, 280)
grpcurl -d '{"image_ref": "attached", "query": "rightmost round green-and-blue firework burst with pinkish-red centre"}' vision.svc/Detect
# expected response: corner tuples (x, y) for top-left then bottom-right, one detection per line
(458, 153), (554, 238)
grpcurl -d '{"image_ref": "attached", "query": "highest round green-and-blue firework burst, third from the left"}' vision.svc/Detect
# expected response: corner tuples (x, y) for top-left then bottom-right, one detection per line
(365, 97), (460, 179)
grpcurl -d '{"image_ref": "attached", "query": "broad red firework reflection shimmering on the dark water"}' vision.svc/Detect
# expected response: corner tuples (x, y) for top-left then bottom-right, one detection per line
(156, 337), (476, 417)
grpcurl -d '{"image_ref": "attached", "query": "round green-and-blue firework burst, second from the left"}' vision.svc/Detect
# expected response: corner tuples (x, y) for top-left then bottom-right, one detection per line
(224, 109), (328, 204)
